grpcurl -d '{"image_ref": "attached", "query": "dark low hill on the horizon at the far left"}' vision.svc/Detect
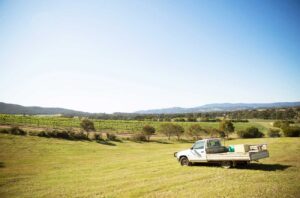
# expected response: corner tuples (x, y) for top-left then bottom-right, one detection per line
(0, 102), (88, 115)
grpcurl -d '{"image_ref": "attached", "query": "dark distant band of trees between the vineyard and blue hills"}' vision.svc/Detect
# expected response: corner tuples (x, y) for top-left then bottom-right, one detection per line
(63, 107), (300, 122)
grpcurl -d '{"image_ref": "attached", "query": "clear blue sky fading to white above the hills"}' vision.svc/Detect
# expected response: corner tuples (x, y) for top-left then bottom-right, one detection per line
(0, 0), (300, 113)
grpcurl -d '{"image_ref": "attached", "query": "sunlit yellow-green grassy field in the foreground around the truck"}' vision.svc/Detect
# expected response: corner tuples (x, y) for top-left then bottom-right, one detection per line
(0, 134), (300, 197)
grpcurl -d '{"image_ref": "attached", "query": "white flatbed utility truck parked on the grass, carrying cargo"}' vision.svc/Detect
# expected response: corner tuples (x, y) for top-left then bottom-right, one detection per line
(174, 138), (269, 168)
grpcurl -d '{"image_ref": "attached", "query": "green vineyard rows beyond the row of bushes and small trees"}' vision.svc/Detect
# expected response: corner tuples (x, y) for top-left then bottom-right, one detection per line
(0, 114), (273, 133)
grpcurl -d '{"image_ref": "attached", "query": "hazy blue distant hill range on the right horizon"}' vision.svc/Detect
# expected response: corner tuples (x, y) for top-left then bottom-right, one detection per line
(135, 102), (300, 114)
